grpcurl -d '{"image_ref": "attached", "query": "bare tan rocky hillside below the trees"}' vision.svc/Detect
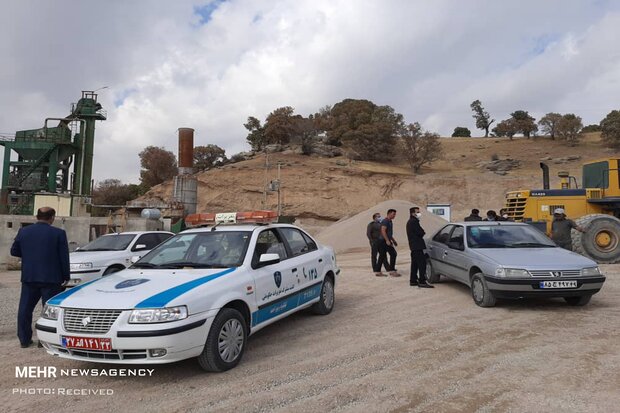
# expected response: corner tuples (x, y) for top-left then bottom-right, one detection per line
(136, 134), (613, 230)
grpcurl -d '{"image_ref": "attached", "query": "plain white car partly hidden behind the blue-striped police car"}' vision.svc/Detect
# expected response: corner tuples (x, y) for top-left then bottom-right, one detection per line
(67, 231), (174, 287)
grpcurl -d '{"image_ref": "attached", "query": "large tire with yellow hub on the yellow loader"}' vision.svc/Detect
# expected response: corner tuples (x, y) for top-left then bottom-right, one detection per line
(571, 214), (620, 264)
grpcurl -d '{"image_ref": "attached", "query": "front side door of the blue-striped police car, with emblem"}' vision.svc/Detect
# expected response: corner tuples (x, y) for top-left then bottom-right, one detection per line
(252, 229), (297, 326)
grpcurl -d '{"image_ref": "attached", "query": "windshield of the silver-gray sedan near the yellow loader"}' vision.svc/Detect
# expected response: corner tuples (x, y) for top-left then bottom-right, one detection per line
(467, 225), (556, 248)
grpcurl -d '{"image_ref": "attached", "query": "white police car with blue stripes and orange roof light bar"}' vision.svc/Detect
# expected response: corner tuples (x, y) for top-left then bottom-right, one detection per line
(36, 211), (340, 371)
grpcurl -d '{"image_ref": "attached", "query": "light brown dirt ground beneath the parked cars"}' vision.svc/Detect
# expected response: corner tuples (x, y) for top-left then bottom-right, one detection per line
(0, 253), (620, 412)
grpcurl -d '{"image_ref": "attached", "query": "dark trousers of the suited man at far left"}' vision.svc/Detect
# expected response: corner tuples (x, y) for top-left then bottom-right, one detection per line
(17, 283), (62, 344)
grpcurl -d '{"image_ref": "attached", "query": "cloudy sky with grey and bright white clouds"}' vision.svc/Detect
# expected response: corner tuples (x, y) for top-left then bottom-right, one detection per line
(0, 0), (620, 183)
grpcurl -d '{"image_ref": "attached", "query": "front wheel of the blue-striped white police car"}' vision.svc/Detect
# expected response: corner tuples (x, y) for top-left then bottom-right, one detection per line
(198, 308), (247, 372)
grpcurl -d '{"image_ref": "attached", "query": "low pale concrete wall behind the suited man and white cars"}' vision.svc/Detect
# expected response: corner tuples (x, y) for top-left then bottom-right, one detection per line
(0, 215), (164, 271)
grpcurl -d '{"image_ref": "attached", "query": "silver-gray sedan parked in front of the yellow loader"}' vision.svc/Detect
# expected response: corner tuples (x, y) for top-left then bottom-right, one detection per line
(426, 222), (605, 307)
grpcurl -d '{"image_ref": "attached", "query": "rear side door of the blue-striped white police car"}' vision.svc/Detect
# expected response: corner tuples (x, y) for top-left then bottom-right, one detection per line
(278, 228), (325, 290)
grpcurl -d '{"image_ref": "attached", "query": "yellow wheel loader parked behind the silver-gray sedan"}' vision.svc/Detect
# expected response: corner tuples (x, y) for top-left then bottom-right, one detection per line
(505, 159), (620, 264)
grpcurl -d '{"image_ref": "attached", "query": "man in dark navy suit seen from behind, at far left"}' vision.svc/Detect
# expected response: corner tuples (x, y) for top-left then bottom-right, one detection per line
(11, 207), (71, 348)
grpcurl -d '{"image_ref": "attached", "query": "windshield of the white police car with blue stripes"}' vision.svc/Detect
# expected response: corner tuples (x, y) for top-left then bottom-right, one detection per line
(133, 231), (252, 269)
